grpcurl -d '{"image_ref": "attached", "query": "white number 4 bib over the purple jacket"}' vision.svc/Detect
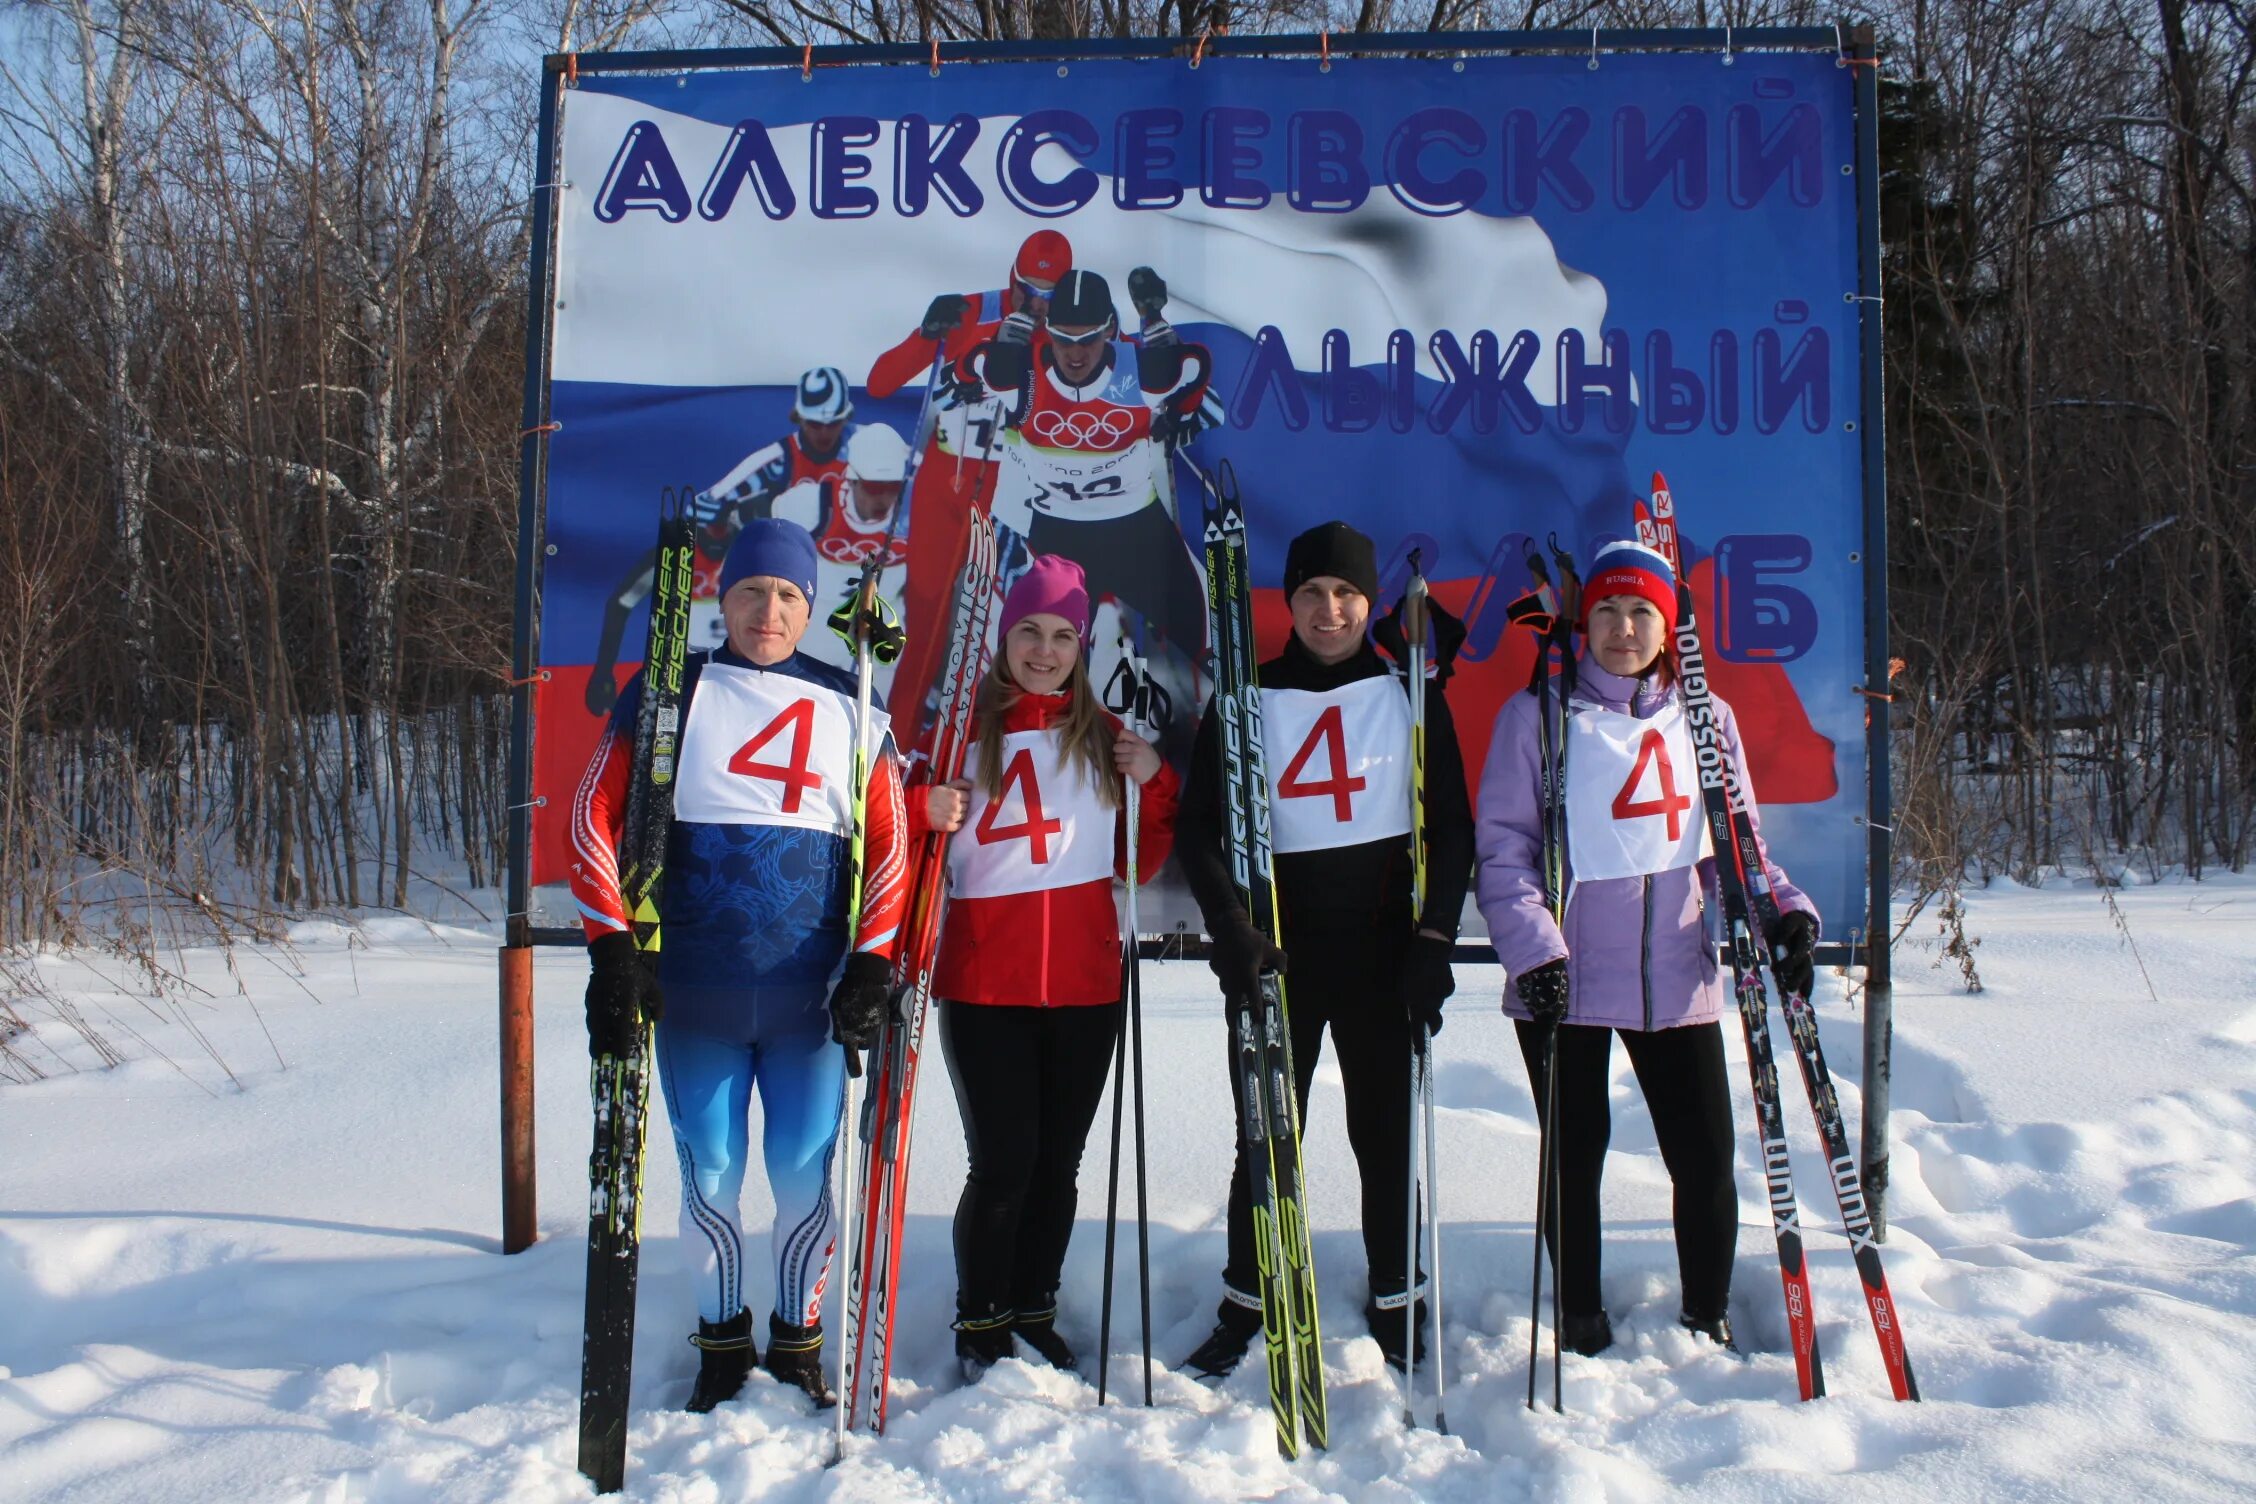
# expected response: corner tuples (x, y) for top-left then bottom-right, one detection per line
(1566, 706), (1708, 882)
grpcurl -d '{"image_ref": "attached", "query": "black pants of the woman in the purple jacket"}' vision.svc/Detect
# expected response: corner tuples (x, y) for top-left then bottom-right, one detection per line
(1518, 1021), (1739, 1317)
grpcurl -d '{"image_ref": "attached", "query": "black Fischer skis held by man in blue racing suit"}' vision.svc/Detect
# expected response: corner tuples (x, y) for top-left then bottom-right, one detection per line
(580, 489), (697, 1493)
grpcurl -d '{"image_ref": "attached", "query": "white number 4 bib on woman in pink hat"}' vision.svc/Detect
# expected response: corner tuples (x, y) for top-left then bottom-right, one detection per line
(948, 731), (1114, 897)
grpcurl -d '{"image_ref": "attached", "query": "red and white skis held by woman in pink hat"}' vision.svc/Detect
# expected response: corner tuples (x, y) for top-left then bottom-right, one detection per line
(839, 512), (997, 1432)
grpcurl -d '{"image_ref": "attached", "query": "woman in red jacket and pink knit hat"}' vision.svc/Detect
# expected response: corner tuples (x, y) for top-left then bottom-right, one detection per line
(918, 555), (1175, 1382)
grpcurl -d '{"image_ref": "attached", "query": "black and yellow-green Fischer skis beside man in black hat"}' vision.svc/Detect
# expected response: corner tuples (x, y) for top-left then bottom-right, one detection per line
(1184, 455), (1331, 1457)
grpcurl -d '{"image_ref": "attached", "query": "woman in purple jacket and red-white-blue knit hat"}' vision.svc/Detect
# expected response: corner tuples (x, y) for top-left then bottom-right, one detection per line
(1478, 543), (1816, 1355)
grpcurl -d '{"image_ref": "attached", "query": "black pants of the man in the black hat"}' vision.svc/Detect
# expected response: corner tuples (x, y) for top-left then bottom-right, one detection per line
(1223, 918), (1412, 1297)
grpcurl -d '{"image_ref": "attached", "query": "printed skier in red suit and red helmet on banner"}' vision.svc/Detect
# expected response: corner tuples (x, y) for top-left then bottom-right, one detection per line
(864, 230), (1074, 749)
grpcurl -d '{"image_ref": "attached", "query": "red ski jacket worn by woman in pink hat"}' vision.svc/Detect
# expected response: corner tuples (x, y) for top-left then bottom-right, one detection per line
(909, 695), (1180, 1008)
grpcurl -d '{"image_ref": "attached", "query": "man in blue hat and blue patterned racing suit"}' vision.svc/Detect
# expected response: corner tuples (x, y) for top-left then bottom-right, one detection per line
(571, 519), (907, 1412)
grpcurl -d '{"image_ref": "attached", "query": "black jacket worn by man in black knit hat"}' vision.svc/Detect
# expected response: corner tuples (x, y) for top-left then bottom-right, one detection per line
(1175, 636), (1473, 949)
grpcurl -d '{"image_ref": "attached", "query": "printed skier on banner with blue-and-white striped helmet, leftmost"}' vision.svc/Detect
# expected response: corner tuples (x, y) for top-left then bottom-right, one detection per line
(587, 365), (853, 715)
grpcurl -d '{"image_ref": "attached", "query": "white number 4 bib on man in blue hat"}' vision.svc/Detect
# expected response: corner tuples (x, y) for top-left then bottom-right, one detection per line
(675, 663), (887, 837)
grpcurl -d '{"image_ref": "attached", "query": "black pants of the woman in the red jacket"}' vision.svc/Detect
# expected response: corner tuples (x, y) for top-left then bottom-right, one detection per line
(941, 999), (1121, 1315)
